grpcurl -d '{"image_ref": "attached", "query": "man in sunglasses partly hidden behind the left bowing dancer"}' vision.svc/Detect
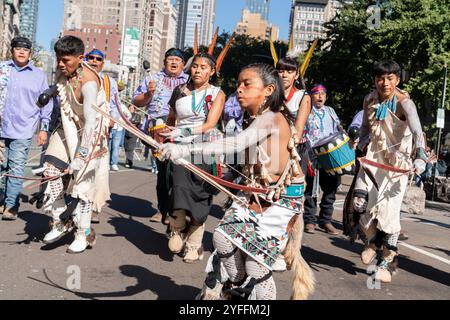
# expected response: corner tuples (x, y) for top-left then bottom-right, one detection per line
(86, 49), (131, 223)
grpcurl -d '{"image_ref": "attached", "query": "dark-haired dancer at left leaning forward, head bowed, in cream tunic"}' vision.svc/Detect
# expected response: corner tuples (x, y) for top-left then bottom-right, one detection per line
(40, 36), (110, 253)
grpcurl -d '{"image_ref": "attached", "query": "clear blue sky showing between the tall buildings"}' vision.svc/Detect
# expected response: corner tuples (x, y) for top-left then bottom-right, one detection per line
(36, 0), (291, 50)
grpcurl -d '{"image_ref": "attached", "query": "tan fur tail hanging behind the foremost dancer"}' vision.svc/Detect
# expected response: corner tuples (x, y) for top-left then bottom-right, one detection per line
(284, 215), (315, 300)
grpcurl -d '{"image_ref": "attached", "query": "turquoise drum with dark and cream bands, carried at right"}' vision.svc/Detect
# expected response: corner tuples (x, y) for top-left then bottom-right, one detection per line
(313, 132), (355, 175)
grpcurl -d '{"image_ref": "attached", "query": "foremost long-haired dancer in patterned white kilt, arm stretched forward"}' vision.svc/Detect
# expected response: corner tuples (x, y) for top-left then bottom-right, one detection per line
(162, 64), (314, 300)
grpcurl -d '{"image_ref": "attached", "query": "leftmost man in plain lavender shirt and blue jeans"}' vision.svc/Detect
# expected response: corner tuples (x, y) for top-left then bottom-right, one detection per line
(0, 37), (53, 220)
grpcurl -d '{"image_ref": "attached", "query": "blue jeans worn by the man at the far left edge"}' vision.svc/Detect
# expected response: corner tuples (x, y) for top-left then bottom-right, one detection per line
(1, 139), (31, 210)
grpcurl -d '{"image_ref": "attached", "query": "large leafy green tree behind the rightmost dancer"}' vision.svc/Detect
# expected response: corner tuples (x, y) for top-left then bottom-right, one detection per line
(307, 0), (450, 134)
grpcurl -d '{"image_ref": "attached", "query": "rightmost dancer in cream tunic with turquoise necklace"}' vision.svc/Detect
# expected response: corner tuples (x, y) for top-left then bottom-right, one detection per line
(352, 61), (428, 282)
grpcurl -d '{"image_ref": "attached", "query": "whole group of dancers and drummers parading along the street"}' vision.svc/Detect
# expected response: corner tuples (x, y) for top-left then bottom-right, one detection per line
(0, 36), (429, 300)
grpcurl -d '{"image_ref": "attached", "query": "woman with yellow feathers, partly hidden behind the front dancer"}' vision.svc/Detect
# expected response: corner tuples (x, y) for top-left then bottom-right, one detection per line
(273, 58), (311, 271)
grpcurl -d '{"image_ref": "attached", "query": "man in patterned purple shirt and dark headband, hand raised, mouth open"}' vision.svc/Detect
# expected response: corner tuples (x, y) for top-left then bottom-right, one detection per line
(133, 48), (188, 222)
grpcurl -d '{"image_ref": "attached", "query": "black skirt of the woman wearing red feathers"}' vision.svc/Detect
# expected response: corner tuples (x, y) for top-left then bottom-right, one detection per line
(171, 164), (213, 224)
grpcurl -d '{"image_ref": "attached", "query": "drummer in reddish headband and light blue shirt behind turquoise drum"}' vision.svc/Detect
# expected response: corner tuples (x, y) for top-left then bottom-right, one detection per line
(304, 84), (341, 235)
